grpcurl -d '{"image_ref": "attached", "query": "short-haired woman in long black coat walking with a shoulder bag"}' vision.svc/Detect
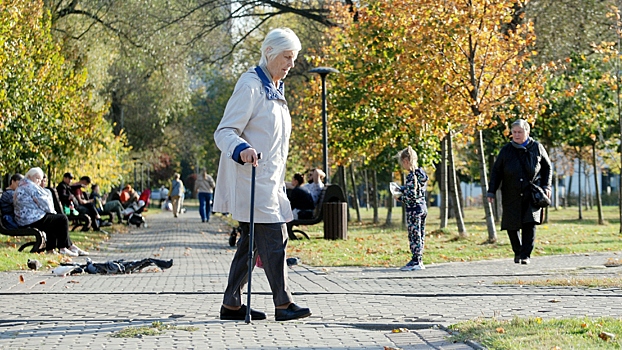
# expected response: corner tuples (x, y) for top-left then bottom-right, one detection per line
(487, 119), (553, 264)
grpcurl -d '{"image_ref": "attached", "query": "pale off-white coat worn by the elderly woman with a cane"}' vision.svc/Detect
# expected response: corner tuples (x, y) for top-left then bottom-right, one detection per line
(214, 68), (293, 224)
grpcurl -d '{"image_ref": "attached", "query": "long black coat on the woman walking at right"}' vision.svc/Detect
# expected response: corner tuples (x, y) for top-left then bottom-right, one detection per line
(487, 138), (553, 230)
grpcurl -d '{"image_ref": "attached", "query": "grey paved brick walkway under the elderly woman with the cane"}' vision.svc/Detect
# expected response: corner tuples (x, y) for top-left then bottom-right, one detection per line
(0, 211), (622, 350)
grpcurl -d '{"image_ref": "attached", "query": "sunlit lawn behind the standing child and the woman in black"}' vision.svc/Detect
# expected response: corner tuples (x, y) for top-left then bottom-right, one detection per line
(288, 207), (622, 267)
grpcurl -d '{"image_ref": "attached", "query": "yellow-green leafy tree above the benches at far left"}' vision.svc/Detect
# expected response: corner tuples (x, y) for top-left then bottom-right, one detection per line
(0, 0), (126, 180)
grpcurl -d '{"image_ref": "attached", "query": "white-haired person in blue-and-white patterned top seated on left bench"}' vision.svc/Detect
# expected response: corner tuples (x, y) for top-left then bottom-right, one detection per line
(13, 168), (89, 257)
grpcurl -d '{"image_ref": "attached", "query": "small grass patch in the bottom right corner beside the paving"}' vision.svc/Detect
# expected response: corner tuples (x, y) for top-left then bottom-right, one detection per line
(450, 318), (622, 350)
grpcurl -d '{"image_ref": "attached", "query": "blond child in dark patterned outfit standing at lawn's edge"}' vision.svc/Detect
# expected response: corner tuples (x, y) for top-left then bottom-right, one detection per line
(398, 146), (428, 271)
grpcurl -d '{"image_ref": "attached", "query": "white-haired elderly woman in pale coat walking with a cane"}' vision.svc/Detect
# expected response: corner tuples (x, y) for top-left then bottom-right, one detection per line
(214, 28), (311, 321)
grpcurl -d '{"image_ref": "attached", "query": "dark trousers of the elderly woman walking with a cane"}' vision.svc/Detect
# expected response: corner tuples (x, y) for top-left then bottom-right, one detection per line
(223, 222), (293, 306)
